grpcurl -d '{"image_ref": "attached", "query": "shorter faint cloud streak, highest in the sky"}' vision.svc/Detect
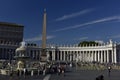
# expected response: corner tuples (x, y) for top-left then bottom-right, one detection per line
(55, 9), (93, 21)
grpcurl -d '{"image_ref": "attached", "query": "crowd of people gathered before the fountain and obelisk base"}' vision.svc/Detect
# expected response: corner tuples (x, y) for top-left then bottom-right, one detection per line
(7, 63), (67, 76)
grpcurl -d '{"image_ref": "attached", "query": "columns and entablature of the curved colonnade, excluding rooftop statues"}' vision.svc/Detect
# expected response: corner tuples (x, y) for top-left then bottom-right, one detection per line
(13, 47), (117, 63)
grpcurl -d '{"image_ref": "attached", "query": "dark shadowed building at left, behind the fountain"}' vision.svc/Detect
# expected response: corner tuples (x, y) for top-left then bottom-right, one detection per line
(0, 22), (24, 60)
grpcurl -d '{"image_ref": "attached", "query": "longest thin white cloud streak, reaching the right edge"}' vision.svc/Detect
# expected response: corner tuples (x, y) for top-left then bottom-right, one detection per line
(54, 16), (120, 32)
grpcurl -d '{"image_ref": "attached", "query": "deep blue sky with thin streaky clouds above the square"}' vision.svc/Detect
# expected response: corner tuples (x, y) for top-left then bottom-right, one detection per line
(0, 0), (120, 44)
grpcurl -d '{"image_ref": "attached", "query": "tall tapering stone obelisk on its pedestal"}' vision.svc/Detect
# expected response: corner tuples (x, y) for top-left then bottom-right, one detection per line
(41, 9), (47, 62)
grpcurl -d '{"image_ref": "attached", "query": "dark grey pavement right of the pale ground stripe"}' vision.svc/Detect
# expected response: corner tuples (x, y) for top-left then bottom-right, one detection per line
(50, 69), (120, 80)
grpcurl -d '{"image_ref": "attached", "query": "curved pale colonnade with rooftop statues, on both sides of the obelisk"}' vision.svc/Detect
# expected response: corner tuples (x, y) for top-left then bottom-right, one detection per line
(24, 40), (120, 63)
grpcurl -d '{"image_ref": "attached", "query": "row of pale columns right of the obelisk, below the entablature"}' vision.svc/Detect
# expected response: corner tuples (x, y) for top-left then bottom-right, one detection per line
(51, 49), (117, 63)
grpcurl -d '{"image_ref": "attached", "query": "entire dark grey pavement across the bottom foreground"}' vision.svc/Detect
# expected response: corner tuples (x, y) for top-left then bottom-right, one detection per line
(0, 68), (120, 80)
